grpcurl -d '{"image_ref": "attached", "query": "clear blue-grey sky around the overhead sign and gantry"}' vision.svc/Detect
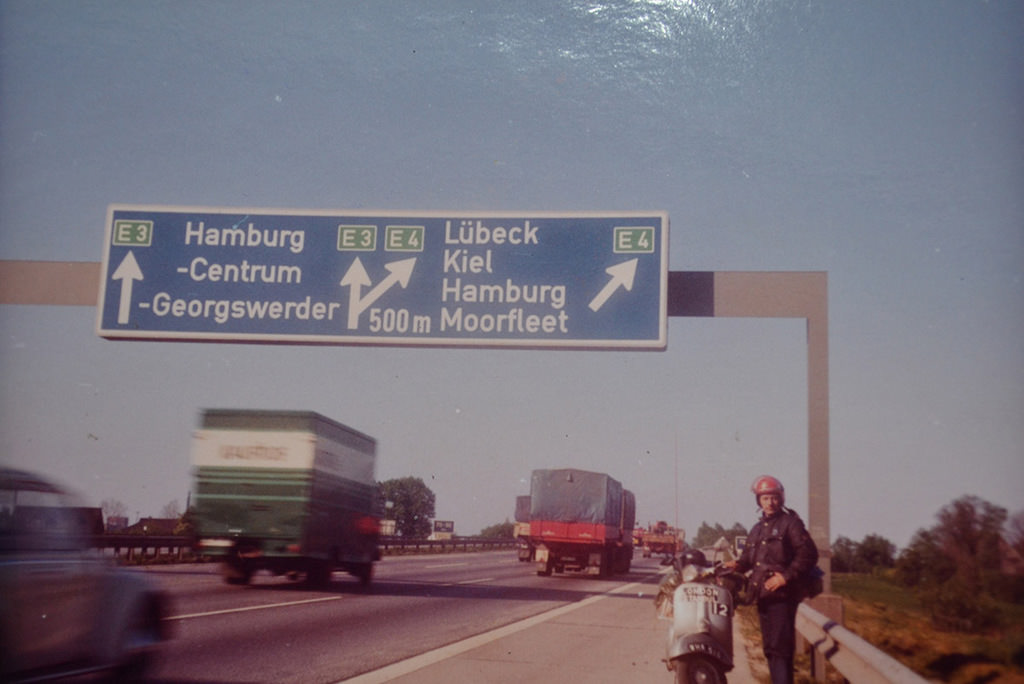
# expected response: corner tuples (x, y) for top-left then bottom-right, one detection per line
(0, 0), (1024, 548)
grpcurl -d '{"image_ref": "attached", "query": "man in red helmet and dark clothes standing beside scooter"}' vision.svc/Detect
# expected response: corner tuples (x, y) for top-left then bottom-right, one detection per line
(726, 475), (818, 684)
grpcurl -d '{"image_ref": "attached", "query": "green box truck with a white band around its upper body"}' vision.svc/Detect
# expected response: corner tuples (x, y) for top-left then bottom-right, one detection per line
(191, 409), (383, 586)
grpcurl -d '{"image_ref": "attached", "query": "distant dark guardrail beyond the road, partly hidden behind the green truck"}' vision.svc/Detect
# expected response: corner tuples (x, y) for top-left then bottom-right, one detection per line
(94, 535), (516, 560)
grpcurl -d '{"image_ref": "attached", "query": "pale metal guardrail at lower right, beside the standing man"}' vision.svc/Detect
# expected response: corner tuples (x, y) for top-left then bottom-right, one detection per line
(797, 603), (928, 684)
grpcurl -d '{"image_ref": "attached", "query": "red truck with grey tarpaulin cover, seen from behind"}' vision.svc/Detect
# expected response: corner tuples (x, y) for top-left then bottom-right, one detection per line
(529, 468), (636, 576)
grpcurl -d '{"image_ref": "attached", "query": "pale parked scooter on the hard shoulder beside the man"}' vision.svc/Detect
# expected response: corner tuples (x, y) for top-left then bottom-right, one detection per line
(655, 550), (746, 684)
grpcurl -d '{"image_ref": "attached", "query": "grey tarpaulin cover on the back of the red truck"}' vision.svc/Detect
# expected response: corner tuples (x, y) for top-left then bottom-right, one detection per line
(529, 468), (623, 527)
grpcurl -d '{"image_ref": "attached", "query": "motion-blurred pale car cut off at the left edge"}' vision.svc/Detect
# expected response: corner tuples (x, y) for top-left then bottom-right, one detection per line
(0, 467), (168, 682)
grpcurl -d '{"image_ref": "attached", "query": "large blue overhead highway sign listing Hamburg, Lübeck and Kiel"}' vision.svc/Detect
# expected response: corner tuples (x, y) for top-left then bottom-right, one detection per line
(96, 205), (669, 349)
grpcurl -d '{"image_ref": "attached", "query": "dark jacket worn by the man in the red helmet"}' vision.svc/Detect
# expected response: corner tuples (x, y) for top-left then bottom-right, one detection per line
(736, 508), (818, 601)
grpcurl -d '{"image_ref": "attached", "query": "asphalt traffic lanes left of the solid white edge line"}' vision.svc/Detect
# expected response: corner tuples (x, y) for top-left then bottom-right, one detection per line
(144, 551), (660, 684)
